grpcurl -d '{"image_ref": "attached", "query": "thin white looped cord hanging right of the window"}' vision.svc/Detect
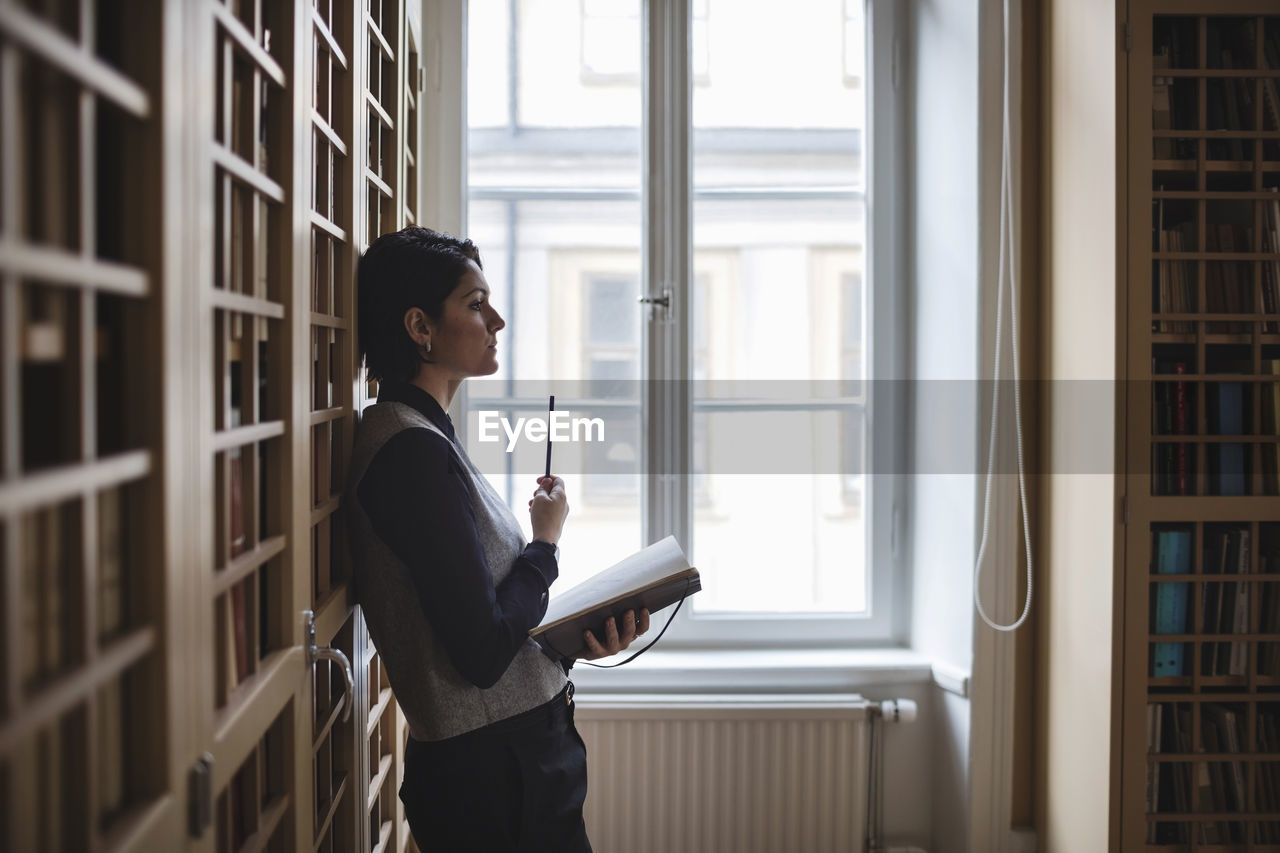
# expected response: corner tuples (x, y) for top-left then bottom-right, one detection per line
(973, 0), (1033, 631)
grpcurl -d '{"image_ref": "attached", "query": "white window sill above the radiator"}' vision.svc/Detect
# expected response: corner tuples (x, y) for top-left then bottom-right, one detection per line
(571, 648), (942, 707)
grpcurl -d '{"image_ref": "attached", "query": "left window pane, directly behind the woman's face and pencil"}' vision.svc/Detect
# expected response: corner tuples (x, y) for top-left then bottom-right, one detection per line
(466, 0), (643, 588)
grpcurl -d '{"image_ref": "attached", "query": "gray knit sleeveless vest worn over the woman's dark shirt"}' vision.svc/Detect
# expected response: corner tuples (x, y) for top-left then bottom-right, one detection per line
(346, 402), (567, 740)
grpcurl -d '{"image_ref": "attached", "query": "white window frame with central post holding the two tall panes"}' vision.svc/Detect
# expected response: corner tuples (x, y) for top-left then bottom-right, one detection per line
(424, 0), (911, 651)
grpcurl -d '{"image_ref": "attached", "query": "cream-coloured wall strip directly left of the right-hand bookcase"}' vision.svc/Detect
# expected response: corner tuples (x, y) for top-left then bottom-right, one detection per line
(1036, 0), (1123, 852)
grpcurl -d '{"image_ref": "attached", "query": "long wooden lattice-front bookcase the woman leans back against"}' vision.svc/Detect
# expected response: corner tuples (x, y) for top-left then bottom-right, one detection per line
(0, 0), (422, 853)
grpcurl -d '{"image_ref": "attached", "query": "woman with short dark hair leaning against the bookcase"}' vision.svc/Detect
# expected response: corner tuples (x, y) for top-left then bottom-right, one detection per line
(346, 228), (649, 853)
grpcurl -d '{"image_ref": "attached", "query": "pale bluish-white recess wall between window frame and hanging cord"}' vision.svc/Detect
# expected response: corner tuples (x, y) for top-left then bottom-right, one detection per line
(906, 0), (980, 853)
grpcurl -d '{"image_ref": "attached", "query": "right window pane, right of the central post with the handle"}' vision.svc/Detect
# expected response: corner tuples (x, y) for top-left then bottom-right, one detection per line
(691, 0), (869, 613)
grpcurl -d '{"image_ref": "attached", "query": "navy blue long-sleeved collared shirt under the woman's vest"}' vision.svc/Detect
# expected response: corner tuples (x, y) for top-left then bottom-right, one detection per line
(358, 383), (572, 688)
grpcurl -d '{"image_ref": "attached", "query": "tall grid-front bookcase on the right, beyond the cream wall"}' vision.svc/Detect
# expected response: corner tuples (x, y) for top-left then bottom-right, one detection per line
(1117, 0), (1280, 852)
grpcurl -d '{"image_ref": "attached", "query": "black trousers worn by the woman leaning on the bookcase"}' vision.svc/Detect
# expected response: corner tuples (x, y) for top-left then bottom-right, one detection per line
(399, 688), (591, 853)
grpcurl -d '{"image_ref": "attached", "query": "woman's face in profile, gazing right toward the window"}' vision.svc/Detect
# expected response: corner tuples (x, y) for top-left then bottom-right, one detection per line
(428, 263), (507, 379)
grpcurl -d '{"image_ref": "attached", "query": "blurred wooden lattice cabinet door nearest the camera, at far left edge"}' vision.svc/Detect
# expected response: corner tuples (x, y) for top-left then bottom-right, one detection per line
(0, 0), (188, 853)
